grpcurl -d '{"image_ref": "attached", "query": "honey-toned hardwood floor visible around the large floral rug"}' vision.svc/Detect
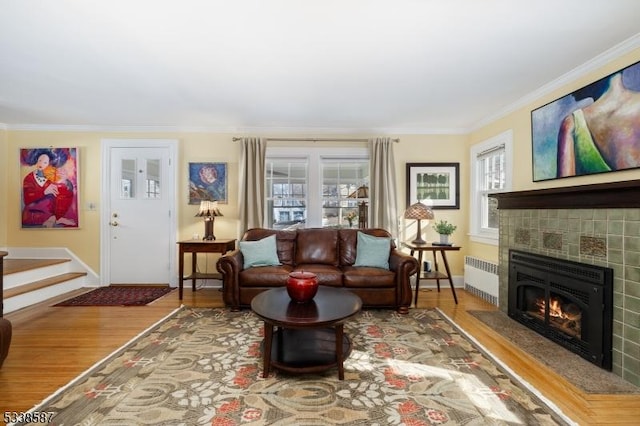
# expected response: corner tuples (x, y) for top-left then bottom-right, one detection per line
(0, 289), (640, 425)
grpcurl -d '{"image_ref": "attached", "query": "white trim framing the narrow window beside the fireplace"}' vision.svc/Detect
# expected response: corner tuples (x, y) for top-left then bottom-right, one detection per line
(469, 130), (513, 246)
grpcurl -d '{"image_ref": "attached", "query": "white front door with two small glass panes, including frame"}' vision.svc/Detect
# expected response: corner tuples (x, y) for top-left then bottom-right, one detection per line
(103, 140), (176, 286)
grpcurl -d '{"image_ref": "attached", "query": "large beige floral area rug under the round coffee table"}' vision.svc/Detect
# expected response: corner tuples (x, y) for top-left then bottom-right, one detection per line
(17, 308), (566, 426)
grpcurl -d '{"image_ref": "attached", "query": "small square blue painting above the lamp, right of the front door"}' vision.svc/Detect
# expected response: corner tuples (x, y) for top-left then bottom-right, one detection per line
(189, 163), (228, 204)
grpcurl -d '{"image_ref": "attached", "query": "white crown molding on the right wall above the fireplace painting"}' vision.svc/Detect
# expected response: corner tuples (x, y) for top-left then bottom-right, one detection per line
(467, 33), (640, 133)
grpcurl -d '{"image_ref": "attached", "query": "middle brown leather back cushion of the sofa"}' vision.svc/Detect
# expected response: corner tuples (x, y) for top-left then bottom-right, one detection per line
(296, 228), (338, 266)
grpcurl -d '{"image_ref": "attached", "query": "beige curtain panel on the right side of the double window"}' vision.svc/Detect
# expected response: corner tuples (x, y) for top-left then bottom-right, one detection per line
(369, 138), (398, 238)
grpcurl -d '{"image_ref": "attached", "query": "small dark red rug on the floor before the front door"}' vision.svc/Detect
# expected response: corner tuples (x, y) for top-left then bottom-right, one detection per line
(54, 285), (173, 306)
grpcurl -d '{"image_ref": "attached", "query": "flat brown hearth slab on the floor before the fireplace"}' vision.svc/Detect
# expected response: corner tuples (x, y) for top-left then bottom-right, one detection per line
(469, 311), (640, 394)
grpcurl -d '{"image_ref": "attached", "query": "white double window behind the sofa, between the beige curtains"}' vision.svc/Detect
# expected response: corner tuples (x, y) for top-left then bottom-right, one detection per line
(265, 147), (369, 229)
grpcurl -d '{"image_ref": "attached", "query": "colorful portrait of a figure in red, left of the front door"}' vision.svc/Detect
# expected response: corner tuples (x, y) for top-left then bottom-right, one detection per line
(20, 148), (79, 229)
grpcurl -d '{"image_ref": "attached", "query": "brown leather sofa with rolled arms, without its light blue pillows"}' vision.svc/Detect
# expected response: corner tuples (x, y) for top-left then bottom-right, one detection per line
(217, 228), (418, 314)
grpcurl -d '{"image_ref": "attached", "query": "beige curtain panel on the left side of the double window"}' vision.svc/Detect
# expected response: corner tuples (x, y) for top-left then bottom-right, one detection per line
(238, 138), (267, 235)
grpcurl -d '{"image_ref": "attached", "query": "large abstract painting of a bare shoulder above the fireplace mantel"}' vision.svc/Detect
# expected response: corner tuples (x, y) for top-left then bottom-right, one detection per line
(531, 62), (640, 182)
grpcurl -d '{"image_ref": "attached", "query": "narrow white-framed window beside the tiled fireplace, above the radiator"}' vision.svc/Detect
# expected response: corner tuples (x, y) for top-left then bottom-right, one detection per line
(470, 130), (513, 244)
